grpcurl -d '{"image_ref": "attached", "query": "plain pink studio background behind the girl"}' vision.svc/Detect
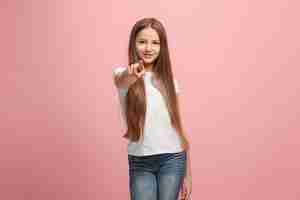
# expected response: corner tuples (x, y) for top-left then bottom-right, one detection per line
(0, 0), (300, 200)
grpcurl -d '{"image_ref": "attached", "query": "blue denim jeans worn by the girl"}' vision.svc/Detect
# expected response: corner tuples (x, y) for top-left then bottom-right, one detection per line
(128, 151), (186, 200)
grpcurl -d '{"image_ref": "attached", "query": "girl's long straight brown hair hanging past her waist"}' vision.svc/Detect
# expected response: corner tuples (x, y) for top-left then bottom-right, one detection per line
(123, 18), (189, 150)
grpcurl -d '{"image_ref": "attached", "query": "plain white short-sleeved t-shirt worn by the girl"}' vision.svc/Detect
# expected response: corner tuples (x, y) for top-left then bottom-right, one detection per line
(113, 67), (183, 156)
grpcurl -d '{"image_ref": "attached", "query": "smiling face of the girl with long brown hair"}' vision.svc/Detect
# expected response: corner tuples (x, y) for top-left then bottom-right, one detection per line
(135, 27), (160, 65)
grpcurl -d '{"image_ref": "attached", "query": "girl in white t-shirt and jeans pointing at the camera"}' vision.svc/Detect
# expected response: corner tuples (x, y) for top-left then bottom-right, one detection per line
(113, 18), (192, 200)
